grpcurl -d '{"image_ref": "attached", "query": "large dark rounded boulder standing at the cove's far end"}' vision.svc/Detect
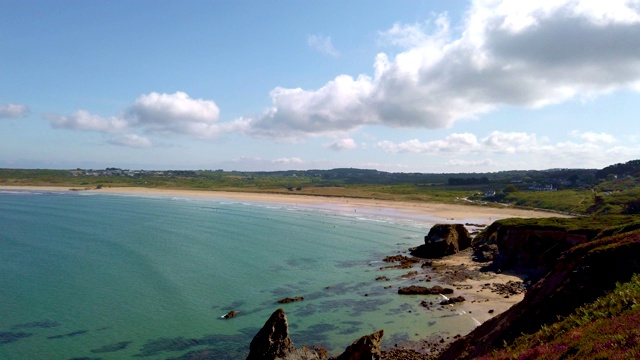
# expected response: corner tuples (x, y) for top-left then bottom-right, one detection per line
(411, 224), (471, 259)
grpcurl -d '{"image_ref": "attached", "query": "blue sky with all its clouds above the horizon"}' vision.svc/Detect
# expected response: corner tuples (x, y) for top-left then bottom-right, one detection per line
(0, 0), (640, 173)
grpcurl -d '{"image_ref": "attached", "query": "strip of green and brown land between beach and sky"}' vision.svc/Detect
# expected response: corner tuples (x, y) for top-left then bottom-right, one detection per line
(0, 160), (640, 215)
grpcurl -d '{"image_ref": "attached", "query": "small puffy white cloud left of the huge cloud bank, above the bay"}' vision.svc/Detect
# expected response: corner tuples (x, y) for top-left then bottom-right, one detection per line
(44, 91), (248, 147)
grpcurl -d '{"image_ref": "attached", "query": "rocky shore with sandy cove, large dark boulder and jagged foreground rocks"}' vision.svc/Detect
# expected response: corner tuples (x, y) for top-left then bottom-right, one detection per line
(242, 225), (526, 360)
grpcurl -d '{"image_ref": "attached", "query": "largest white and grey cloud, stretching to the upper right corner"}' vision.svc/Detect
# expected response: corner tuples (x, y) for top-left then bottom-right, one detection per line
(242, 0), (640, 138)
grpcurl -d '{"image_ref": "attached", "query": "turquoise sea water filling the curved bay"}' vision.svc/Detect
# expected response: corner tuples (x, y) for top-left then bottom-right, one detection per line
(0, 191), (475, 360)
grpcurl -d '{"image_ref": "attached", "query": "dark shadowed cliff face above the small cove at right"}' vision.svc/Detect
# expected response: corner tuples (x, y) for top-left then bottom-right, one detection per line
(439, 226), (640, 359)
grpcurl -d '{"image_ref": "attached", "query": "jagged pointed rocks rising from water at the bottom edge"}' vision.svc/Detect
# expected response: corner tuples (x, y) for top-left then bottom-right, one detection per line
(247, 309), (383, 360)
